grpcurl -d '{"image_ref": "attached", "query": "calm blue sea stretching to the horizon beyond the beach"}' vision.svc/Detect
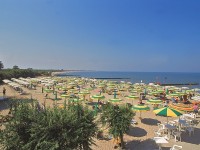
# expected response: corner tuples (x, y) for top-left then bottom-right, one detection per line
(61, 71), (200, 89)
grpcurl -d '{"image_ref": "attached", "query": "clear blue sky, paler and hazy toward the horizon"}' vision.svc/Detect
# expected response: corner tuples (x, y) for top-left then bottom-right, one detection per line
(0, 0), (200, 72)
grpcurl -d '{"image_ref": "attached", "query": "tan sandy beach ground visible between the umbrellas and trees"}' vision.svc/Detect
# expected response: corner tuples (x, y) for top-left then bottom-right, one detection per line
(0, 77), (200, 150)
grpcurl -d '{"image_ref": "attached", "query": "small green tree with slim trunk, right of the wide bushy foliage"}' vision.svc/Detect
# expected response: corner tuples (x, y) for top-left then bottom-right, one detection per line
(101, 103), (135, 148)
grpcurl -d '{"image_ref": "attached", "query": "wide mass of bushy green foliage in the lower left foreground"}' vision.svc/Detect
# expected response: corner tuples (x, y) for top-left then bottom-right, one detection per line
(0, 100), (97, 150)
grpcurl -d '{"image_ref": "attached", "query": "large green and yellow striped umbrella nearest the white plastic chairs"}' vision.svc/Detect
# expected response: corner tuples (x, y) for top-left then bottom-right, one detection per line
(153, 107), (183, 122)
